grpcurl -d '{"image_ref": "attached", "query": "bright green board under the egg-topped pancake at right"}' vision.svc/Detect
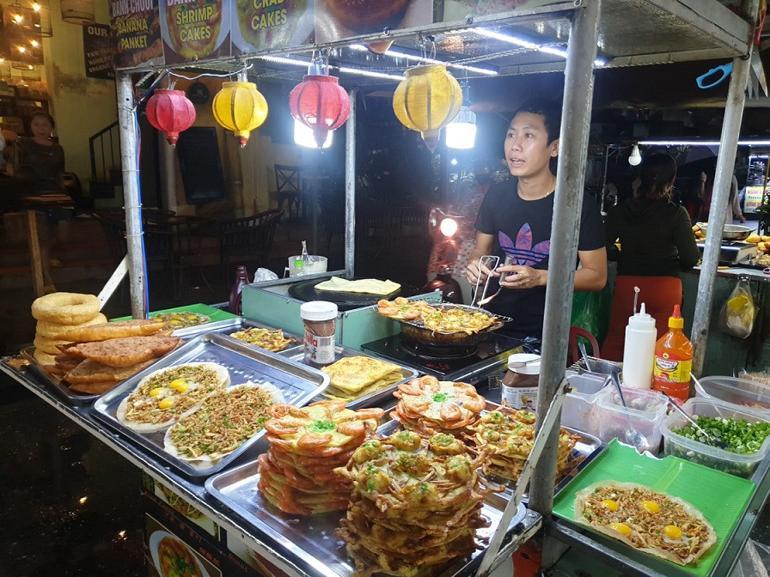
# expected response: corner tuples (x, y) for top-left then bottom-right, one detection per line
(553, 439), (755, 577)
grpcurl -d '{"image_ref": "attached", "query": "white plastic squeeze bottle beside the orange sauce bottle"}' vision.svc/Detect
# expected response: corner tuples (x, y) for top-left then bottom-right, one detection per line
(623, 303), (658, 389)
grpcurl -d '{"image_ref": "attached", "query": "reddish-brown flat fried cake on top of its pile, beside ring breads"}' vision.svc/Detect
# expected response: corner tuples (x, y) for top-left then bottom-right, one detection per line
(62, 335), (182, 367)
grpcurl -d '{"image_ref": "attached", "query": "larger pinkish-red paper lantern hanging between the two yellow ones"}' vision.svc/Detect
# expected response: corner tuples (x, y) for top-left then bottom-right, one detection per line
(289, 74), (350, 148)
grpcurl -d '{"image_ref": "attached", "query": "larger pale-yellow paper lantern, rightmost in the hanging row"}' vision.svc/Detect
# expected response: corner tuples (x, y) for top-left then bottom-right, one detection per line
(393, 64), (463, 146)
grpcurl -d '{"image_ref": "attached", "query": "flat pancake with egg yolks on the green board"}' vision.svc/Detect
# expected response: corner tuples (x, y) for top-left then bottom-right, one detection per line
(575, 481), (717, 565)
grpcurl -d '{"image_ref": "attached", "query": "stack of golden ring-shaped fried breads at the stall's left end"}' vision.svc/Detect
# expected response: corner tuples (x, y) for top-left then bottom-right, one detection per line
(32, 293), (107, 367)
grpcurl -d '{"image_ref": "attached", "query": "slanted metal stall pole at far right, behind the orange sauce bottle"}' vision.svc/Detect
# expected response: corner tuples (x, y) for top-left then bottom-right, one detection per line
(690, 31), (756, 376)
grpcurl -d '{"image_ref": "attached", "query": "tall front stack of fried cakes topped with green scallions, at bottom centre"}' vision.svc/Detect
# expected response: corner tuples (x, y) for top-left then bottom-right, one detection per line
(338, 430), (486, 577)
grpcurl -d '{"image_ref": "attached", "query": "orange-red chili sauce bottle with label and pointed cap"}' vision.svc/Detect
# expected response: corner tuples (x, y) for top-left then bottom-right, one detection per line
(652, 305), (692, 402)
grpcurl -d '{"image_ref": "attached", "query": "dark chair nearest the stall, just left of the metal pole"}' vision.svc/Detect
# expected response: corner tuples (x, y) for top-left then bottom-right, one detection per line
(219, 209), (283, 281)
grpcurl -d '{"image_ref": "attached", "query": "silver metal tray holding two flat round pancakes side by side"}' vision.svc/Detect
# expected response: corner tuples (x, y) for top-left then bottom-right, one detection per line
(91, 334), (329, 478)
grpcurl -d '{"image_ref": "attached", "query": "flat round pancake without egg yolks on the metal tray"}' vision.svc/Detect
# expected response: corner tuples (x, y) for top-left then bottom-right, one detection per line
(164, 383), (284, 465)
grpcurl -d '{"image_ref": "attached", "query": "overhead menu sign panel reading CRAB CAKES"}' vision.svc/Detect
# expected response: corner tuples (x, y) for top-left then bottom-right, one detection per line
(232, 0), (315, 54)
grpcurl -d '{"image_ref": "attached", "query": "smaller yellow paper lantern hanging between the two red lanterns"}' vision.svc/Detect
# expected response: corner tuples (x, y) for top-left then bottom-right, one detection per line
(211, 80), (267, 148)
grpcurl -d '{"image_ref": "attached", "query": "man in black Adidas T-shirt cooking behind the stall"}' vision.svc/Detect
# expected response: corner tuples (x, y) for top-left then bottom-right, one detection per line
(466, 102), (607, 339)
